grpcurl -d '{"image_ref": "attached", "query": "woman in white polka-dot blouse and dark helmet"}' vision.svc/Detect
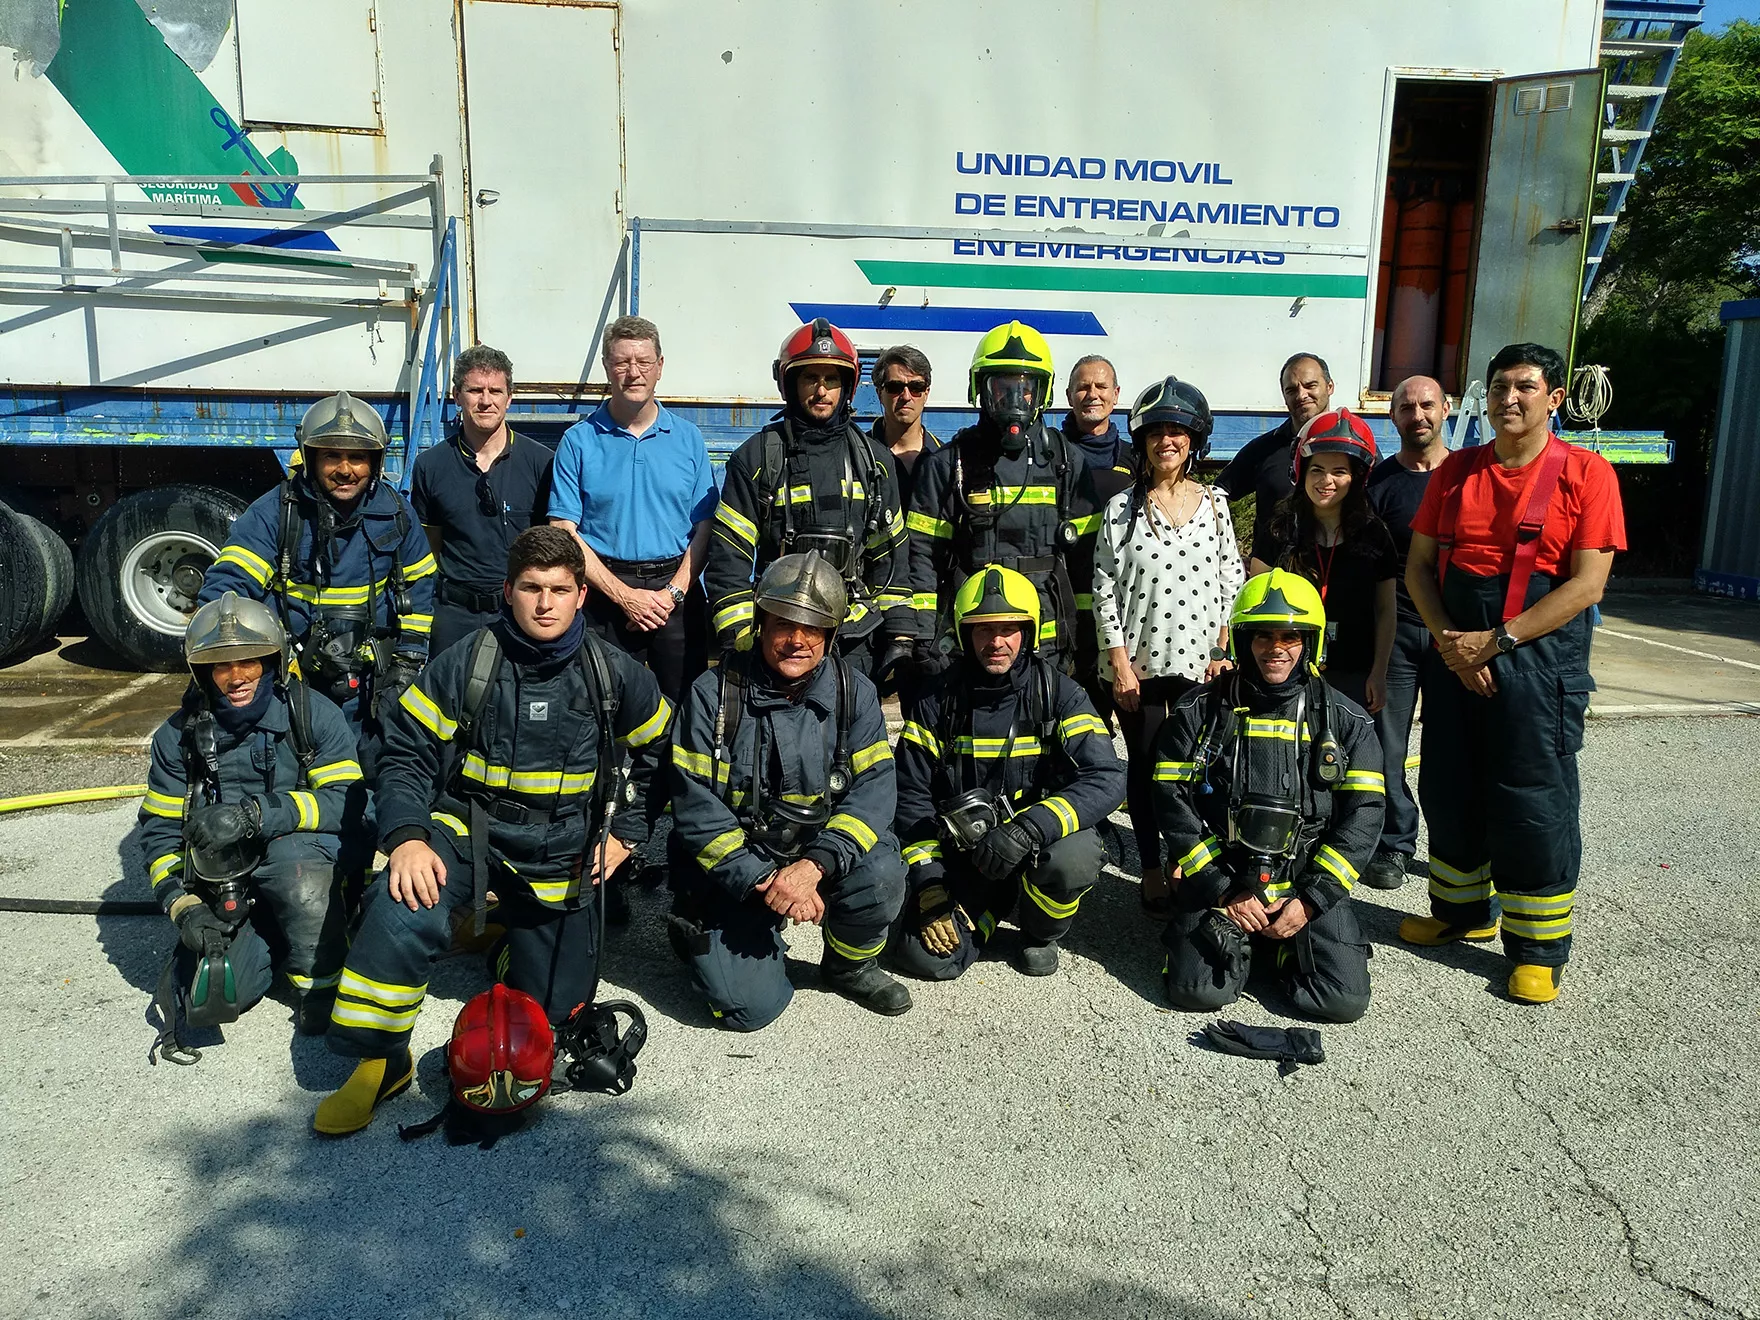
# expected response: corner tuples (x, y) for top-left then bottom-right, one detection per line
(1095, 377), (1246, 919)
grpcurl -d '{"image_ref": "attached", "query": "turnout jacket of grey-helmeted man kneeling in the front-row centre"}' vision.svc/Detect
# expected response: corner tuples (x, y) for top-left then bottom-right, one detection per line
(672, 655), (898, 901)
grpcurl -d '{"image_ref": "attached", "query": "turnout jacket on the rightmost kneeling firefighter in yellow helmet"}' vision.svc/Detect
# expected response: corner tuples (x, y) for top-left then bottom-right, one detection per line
(1151, 671), (1387, 912)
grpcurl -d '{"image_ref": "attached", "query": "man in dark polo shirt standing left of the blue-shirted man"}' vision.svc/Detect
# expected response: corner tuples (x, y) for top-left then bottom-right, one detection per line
(410, 343), (556, 655)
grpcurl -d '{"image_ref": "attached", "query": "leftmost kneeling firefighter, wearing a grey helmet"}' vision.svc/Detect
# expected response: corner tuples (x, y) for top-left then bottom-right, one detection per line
(141, 591), (361, 1063)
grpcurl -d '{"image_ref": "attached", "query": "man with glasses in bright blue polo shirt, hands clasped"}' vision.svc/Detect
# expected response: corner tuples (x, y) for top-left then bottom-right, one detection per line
(549, 317), (716, 706)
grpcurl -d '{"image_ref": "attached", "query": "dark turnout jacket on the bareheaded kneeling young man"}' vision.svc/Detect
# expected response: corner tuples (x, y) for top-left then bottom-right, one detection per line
(375, 623), (672, 906)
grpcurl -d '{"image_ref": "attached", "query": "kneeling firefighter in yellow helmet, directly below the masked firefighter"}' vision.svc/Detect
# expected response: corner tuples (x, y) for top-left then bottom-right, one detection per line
(894, 565), (1125, 980)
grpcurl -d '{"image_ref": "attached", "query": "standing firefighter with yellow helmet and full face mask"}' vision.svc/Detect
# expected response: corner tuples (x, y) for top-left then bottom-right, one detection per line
(905, 320), (1100, 672)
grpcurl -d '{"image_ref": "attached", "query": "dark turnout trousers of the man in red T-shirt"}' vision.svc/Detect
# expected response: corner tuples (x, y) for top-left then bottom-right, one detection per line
(1419, 567), (1595, 966)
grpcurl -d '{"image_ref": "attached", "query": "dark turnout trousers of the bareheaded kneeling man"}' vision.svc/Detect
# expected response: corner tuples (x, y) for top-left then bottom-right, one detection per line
(329, 829), (598, 1060)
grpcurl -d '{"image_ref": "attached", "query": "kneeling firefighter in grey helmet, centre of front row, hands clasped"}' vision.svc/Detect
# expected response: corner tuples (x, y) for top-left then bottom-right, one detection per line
(671, 551), (910, 1031)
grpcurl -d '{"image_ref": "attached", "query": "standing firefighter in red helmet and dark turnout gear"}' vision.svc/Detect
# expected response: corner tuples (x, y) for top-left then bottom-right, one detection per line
(702, 317), (915, 676)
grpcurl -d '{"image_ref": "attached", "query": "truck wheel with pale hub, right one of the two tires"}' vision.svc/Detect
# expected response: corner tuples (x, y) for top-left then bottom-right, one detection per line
(77, 486), (245, 672)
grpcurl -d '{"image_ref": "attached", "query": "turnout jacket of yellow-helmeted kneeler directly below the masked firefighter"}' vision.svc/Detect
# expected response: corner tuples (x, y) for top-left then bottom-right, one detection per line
(898, 658), (1125, 885)
